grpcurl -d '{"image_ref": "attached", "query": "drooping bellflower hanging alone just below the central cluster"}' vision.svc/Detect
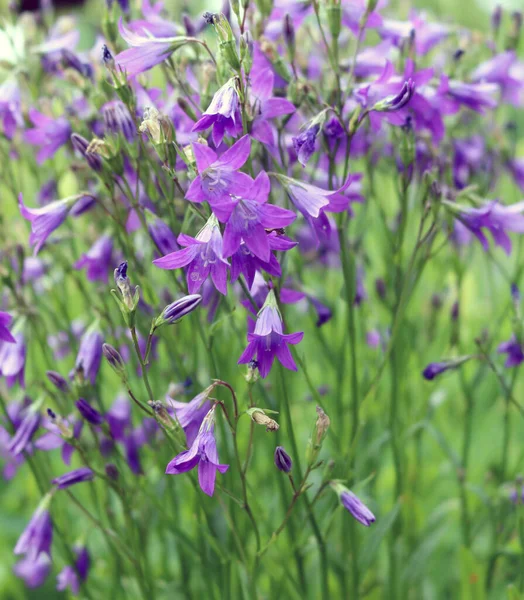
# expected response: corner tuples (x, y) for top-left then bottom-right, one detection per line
(238, 290), (304, 378)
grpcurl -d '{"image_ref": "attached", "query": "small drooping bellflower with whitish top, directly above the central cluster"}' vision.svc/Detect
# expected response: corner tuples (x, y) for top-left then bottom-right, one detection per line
(192, 78), (242, 146)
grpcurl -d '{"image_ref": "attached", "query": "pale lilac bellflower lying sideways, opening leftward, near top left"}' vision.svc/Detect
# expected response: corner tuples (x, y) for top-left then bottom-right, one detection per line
(115, 19), (186, 77)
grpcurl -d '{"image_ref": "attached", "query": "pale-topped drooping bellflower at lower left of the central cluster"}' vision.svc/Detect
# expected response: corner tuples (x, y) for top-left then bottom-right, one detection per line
(153, 215), (229, 295)
